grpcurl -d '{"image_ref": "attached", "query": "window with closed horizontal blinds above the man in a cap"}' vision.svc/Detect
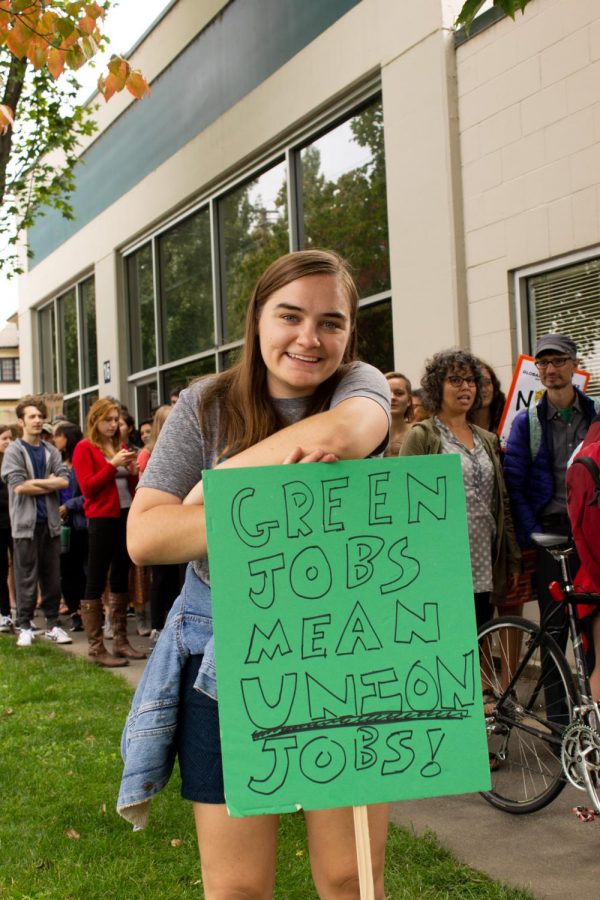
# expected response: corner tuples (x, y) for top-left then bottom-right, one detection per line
(526, 256), (600, 395)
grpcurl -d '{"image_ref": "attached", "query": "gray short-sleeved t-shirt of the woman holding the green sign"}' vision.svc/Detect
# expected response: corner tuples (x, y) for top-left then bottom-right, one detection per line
(139, 362), (390, 583)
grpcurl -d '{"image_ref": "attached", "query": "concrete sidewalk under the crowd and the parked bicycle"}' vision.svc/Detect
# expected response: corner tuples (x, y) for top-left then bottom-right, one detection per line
(48, 618), (600, 900)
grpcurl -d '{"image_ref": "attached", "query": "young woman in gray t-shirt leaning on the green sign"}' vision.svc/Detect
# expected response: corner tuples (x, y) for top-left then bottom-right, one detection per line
(118, 250), (390, 900)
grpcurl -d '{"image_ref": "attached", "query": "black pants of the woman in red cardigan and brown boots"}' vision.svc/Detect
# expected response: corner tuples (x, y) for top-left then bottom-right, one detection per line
(85, 509), (131, 600)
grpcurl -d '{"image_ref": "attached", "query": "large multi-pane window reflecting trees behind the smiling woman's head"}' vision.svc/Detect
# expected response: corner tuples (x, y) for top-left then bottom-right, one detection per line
(125, 92), (394, 419)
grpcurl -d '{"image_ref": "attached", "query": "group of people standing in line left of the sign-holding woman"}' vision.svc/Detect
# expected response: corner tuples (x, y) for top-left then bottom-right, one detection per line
(0, 389), (181, 667)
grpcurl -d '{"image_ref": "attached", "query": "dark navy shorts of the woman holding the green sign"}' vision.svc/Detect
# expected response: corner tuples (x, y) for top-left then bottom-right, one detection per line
(177, 655), (225, 803)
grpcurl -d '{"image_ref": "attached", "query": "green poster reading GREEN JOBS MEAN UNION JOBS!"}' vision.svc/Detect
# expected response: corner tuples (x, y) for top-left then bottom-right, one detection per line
(204, 454), (490, 816)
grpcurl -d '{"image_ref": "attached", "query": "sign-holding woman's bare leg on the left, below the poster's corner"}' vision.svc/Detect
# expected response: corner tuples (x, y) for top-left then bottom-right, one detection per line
(192, 803), (279, 900)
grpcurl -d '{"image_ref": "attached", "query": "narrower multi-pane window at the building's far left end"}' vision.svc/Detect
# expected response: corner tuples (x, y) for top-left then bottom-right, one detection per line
(38, 278), (98, 424)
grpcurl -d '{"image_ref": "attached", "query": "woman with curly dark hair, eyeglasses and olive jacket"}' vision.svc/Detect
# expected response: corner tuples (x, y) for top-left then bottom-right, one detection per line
(400, 350), (520, 627)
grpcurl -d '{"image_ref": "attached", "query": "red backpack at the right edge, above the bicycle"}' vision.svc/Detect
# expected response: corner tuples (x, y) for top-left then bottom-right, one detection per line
(567, 418), (600, 591)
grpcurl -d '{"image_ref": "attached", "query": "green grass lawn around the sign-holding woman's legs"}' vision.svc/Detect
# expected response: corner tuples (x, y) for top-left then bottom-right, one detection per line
(0, 635), (530, 900)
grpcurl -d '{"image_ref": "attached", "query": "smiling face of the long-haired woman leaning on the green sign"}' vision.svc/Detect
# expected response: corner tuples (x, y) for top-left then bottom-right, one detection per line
(258, 275), (350, 399)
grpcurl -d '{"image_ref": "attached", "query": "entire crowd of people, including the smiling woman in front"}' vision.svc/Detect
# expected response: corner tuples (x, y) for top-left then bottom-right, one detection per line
(0, 250), (600, 898)
